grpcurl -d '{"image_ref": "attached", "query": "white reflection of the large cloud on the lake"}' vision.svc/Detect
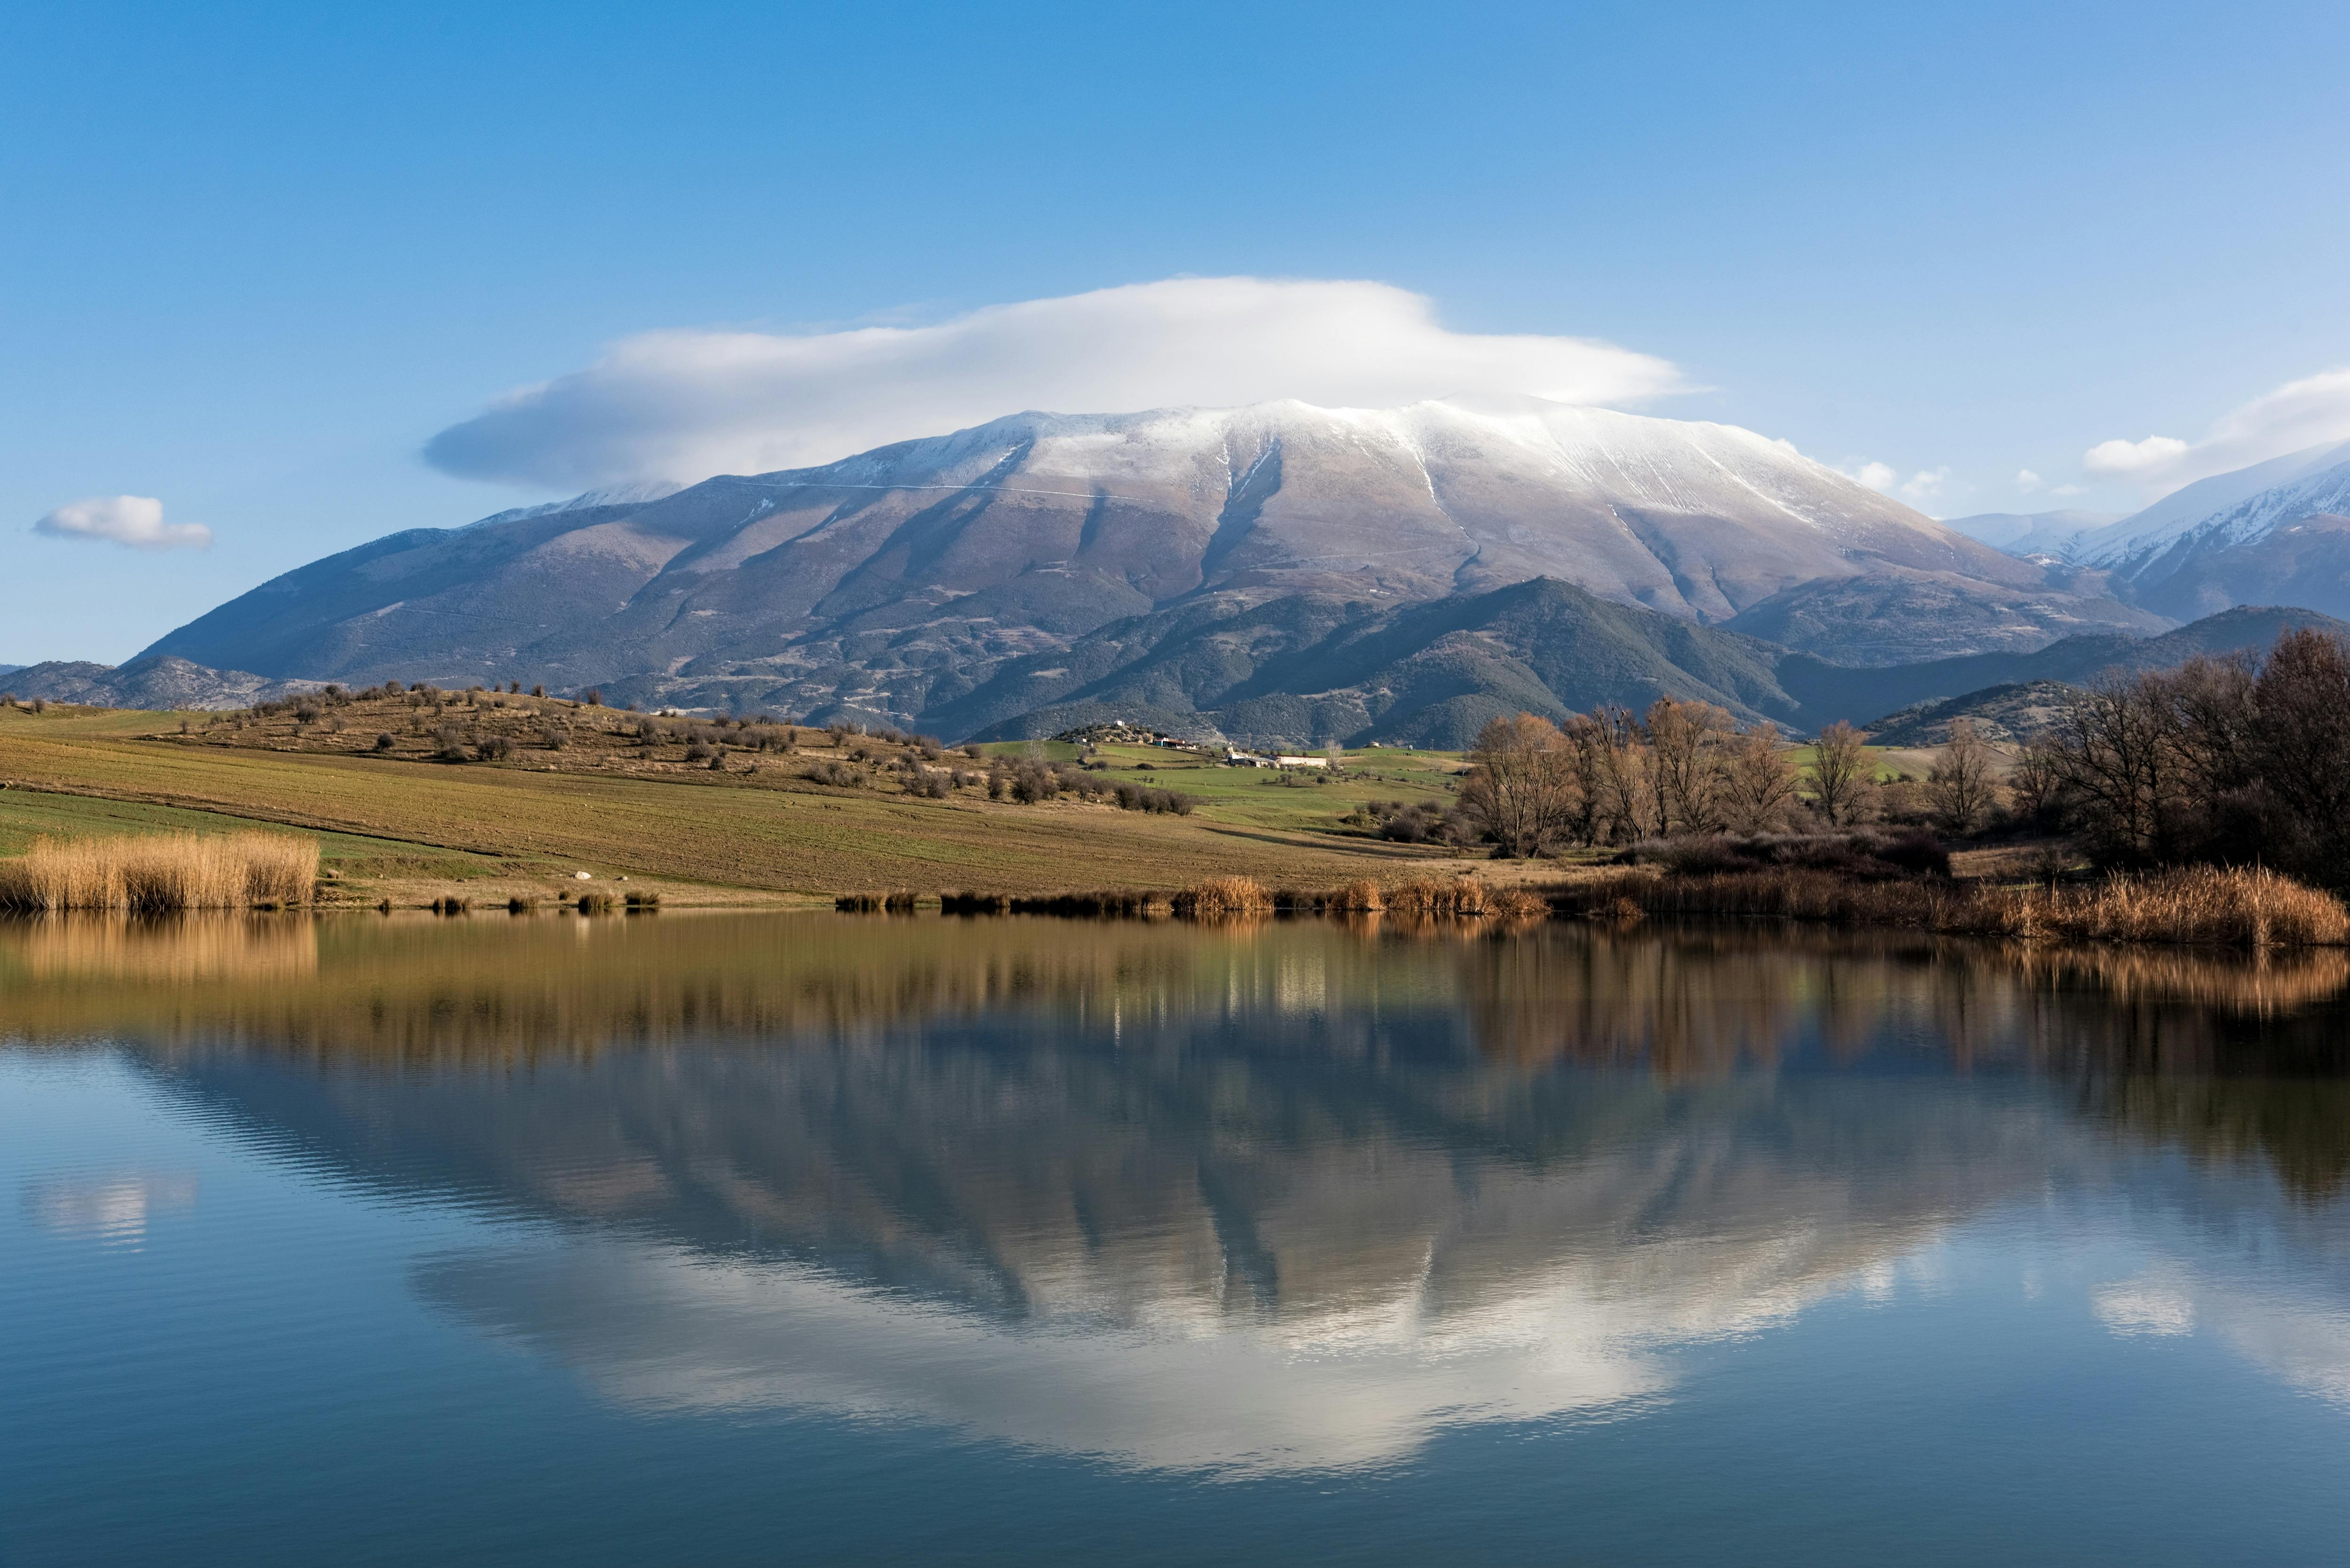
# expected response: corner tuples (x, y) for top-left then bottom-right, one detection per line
(418, 1239), (1918, 1474)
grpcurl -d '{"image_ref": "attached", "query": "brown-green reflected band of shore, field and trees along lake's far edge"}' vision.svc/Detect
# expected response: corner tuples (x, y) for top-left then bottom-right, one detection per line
(0, 917), (2350, 1203)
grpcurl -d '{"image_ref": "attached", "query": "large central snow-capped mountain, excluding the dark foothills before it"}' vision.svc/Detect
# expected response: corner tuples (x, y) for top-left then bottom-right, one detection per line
(133, 400), (2160, 729)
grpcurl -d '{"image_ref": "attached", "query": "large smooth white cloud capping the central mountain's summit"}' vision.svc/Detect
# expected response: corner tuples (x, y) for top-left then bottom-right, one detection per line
(425, 277), (1683, 489)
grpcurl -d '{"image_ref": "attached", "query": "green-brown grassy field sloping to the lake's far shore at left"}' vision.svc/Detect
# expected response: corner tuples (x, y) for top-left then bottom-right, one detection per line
(0, 710), (1459, 903)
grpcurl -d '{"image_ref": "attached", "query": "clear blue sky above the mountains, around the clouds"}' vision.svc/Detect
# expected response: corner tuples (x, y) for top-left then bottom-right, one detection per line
(0, 0), (2350, 663)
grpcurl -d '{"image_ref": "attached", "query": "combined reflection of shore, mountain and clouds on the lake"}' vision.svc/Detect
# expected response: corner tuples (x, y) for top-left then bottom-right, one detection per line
(14, 919), (2350, 1467)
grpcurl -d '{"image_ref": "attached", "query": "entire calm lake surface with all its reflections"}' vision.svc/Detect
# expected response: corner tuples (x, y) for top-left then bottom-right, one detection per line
(0, 914), (2350, 1563)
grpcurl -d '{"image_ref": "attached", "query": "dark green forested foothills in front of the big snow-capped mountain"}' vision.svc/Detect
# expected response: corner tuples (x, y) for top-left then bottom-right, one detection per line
(928, 578), (1798, 748)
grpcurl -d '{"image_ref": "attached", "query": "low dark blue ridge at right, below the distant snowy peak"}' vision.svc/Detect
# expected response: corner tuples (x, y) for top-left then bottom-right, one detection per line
(1774, 607), (2350, 729)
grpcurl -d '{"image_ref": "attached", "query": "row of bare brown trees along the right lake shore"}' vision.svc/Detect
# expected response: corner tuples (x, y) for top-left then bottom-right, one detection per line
(1448, 630), (2350, 886)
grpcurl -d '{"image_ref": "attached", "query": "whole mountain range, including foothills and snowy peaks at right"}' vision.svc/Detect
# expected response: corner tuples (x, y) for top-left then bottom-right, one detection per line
(32, 400), (2350, 745)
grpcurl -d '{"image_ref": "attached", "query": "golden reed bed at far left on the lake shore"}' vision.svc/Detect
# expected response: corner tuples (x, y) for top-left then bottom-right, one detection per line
(0, 832), (317, 914)
